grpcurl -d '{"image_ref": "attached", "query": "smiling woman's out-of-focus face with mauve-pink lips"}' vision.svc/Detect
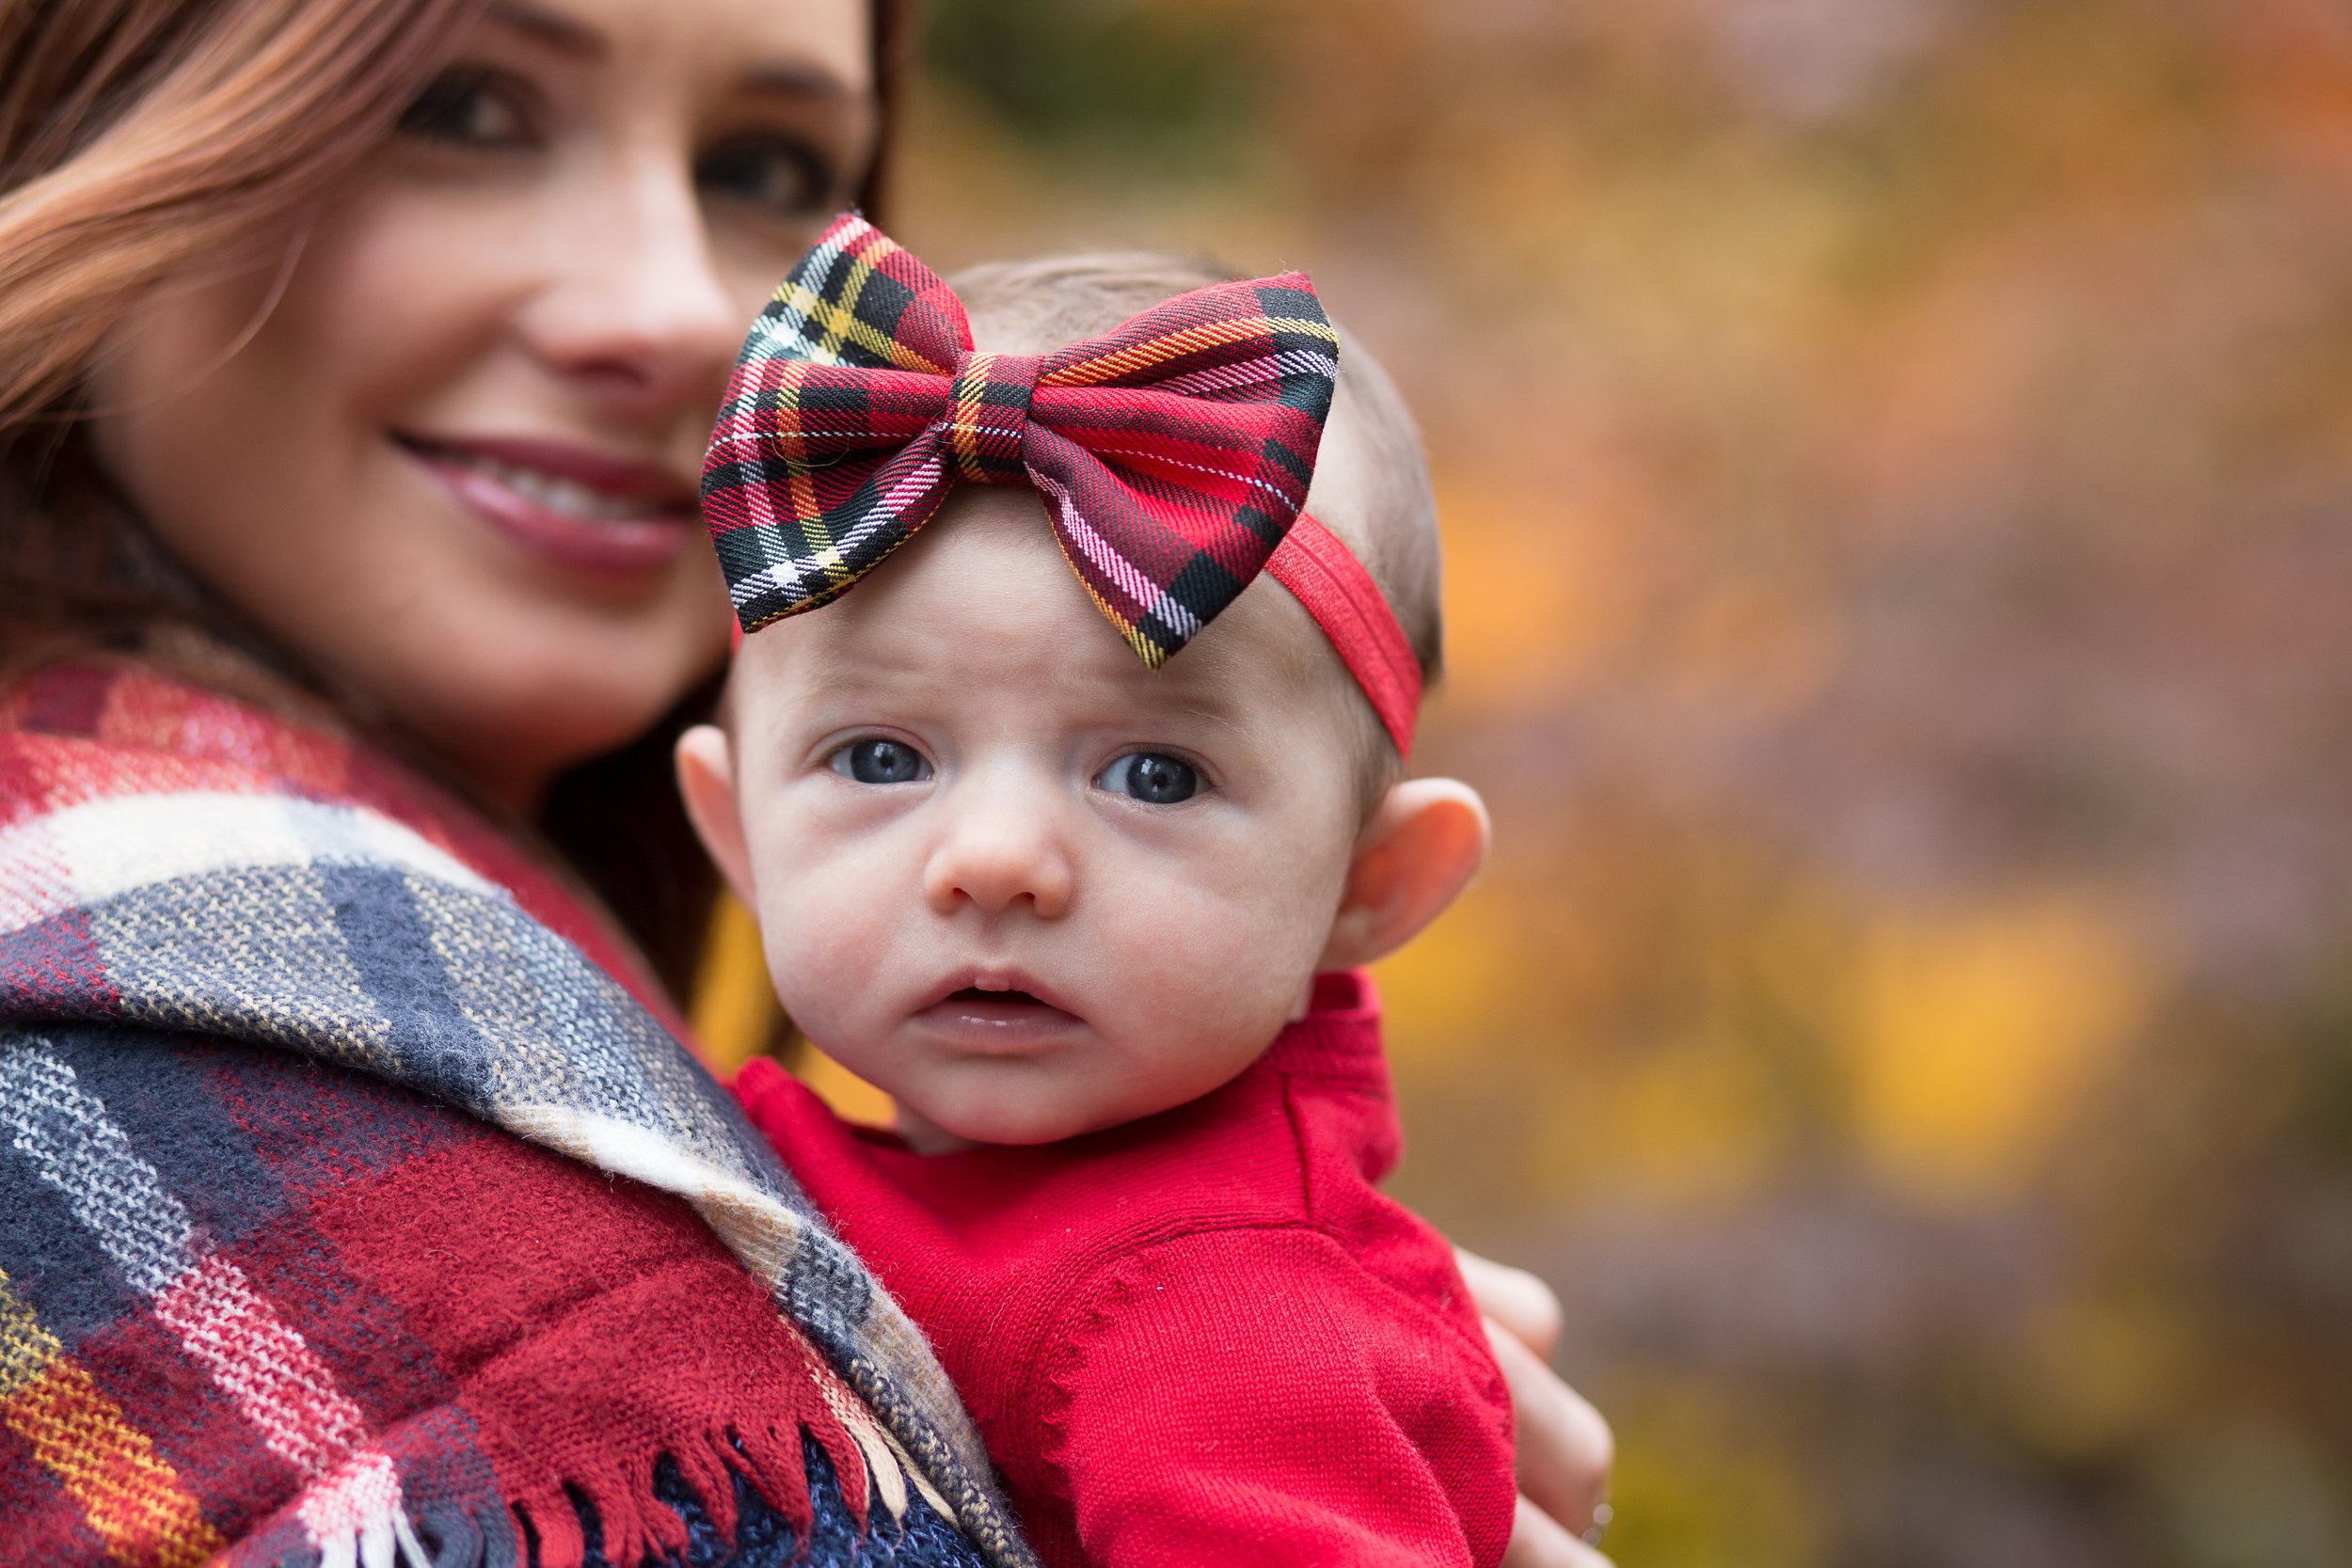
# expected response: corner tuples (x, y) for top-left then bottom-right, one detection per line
(89, 0), (875, 809)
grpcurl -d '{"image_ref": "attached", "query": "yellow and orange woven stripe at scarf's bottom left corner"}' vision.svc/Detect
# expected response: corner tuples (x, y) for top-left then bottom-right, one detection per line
(0, 1275), (229, 1568)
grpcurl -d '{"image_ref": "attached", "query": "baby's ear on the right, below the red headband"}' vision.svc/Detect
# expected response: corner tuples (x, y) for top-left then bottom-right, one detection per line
(1315, 778), (1491, 974)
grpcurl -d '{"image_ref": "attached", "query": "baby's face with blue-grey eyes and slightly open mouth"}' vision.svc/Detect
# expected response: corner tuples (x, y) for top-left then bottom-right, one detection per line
(734, 489), (1359, 1148)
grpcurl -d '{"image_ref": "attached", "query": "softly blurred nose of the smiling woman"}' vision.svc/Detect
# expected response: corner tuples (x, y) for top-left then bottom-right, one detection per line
(520, 150), (751, 414)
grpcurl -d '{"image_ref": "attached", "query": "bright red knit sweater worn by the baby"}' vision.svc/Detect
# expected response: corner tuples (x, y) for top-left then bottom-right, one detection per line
(737, 975), (1515, 1568)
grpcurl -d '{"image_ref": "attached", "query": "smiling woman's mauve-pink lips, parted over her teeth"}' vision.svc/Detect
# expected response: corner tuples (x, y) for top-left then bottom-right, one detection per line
(398, 437), (701, 576)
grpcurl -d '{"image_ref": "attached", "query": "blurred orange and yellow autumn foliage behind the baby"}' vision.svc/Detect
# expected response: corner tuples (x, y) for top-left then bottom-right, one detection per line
(894, 0), (2352, 1568)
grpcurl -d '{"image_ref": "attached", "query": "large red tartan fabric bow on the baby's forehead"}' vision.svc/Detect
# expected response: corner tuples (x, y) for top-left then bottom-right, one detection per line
(704, 214), (1339, 668)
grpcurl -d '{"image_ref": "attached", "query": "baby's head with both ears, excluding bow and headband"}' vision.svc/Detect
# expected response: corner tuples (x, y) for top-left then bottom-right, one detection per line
(677, 256), (1486, 1148)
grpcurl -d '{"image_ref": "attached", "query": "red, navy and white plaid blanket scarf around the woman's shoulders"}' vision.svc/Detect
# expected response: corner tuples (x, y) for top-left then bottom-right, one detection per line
(0, 665), (1030, 1568)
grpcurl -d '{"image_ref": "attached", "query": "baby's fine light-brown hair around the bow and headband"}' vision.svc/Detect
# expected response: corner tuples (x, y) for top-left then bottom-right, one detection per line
(950, 251), (1444, 761)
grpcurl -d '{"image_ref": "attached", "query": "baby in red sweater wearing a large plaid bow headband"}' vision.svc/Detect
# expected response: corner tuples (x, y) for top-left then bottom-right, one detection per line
(677, 218), (1513, 1568)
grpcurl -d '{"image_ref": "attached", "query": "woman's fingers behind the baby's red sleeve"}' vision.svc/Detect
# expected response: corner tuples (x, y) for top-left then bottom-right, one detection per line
(1454, 1248), (1616, 1568)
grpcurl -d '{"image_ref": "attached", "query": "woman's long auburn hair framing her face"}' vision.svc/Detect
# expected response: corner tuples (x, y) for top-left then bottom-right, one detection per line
(0, 0), (908, 992)
